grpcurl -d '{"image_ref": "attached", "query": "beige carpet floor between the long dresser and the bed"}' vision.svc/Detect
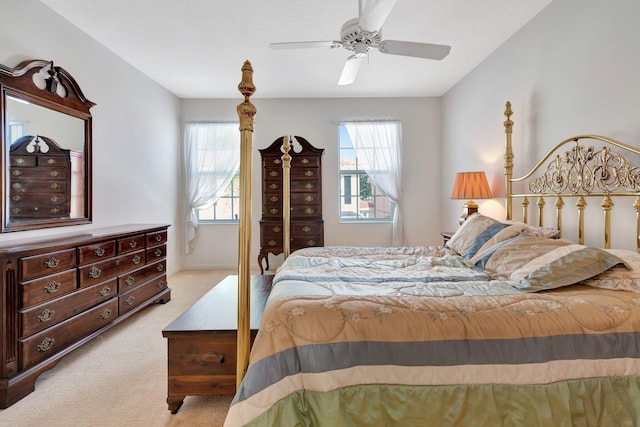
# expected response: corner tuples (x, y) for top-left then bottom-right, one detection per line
(0, 271), (237, 427)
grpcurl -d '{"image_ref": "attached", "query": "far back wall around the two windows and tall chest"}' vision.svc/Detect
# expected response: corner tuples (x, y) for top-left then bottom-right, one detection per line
(182, 97), (442, 269)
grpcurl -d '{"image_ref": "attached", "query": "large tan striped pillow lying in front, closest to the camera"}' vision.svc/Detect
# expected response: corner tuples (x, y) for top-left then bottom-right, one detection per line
(472, 235), (625, 292)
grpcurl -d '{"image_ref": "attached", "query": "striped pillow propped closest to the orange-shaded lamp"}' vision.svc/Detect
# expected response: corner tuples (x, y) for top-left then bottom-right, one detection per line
(447, 213), (524, 258)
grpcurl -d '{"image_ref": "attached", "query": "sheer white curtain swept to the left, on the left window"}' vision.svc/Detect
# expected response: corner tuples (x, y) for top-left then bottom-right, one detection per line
(184, 123), (240, 253)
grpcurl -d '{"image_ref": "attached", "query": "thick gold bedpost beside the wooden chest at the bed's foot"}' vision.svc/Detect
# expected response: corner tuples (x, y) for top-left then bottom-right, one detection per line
(236, 61), (256, 389)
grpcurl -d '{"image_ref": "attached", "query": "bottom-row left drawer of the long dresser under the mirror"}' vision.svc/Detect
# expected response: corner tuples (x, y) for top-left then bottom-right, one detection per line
(20, 298), (118, 370)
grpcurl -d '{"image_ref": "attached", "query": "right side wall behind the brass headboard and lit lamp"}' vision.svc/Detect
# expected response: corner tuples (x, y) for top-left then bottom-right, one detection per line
(442, 0), (640, 249)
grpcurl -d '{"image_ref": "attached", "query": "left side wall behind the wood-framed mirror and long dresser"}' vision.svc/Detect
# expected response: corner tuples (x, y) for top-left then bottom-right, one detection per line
(0, 0), (181, 274)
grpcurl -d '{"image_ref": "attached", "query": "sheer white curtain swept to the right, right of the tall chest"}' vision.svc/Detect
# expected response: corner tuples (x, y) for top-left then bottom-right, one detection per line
(344, 122), (405, 246)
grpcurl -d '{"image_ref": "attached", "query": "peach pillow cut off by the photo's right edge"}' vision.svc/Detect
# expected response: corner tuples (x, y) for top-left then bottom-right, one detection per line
(582, 249), (640, 293)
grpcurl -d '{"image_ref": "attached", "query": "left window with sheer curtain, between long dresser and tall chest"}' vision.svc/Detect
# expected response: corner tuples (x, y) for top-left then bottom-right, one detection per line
(184, 123), (240, 253)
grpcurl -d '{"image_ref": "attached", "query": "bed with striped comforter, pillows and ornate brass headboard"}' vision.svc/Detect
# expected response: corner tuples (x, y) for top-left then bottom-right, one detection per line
(225, 66), (640, 427)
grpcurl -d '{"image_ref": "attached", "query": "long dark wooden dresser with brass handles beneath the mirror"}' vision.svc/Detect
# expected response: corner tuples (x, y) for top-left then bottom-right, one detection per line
(0, 225), (171, 408)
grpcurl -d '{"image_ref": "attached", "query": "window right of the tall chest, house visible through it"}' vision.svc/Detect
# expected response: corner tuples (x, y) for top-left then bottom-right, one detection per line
(339, 122), (400, 222)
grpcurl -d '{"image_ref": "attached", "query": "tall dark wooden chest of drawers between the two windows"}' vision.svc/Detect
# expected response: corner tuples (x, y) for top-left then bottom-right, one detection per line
(258, 136), (324, 273)
